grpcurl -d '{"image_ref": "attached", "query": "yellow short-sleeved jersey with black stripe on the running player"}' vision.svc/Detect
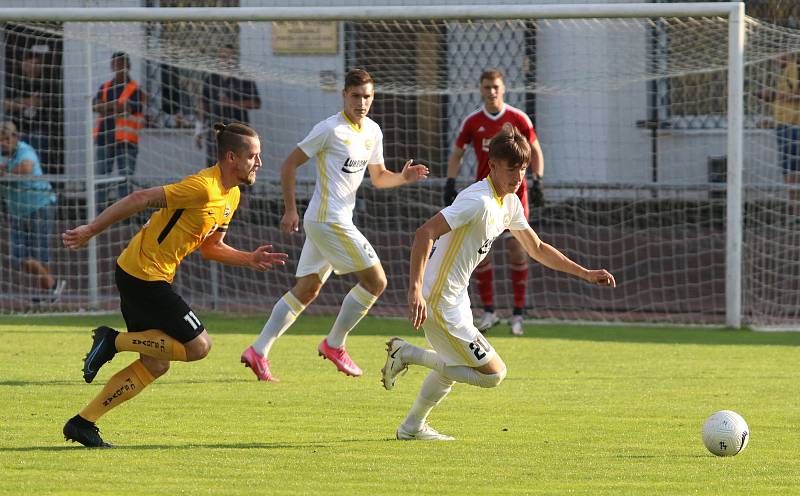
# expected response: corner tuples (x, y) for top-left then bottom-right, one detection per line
(117, 165), (239, 282)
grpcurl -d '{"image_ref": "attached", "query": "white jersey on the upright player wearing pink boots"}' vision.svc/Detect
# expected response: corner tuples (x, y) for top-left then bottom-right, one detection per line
(297, 112), (383, 224)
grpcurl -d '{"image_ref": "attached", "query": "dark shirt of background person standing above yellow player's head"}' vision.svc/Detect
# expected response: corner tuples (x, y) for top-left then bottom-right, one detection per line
(203, 74), (261, 125)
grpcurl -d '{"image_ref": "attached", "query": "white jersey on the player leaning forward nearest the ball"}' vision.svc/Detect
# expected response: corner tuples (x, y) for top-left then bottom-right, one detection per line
(422, 177), (529, 305)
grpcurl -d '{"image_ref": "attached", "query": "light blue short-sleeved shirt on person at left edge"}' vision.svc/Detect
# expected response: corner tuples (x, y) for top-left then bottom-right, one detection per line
(2, 141), (56, 217)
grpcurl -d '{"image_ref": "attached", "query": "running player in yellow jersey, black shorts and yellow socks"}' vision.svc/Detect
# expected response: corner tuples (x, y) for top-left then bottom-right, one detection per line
(62, 123), (287, 447)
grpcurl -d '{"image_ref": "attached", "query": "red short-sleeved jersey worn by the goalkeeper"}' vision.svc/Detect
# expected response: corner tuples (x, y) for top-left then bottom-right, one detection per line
(456, 103), (537, 195)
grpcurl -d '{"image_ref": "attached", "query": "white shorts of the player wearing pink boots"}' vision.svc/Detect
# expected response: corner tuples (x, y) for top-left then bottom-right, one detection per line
(295, 221), (380, 282)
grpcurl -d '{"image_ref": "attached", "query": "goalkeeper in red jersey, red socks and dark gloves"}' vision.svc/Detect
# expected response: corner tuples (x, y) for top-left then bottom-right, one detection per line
(444, 69), (544, 335)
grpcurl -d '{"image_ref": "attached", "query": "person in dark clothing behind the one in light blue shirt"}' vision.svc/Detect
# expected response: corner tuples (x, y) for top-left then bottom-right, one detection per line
(3, 45), (55, 170)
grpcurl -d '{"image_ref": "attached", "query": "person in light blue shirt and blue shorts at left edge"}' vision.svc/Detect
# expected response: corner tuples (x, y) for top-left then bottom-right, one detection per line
(0, 121), (67, 301)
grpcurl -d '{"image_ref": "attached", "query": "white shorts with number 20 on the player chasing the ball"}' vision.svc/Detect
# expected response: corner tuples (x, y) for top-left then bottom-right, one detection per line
(422, 297), (496, 367)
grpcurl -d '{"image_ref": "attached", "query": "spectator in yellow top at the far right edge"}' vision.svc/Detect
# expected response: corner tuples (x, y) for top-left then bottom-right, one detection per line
(774, 55), (800, 219)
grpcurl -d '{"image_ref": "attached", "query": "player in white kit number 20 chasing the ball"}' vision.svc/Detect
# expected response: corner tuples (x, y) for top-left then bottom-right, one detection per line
(382, 125), (616, 441)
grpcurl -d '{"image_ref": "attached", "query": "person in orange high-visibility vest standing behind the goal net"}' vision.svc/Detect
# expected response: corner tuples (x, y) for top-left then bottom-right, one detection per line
(92, 52), (146, 211)
